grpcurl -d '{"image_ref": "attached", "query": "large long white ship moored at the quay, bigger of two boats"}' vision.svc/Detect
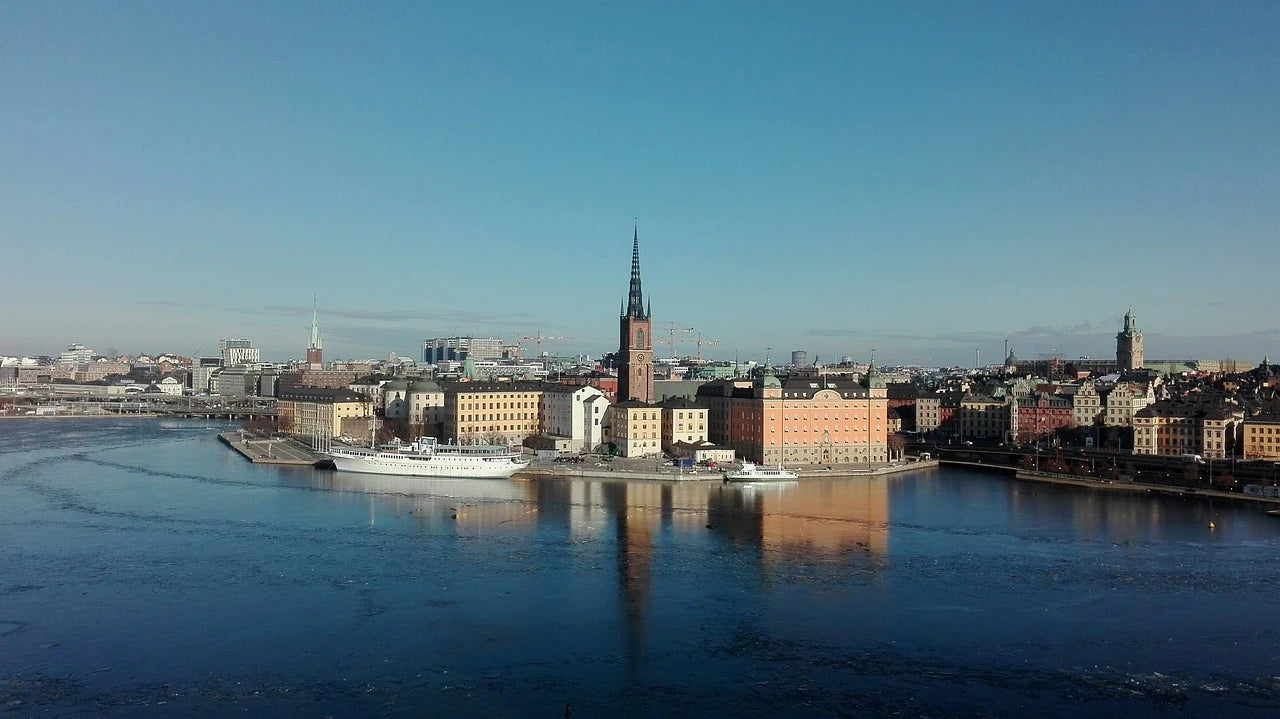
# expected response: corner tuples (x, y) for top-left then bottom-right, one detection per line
(329, 438), (529, 478)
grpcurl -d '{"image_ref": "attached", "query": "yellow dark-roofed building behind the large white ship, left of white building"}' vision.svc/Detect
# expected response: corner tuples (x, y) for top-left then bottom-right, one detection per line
(442, 381), (543, 445)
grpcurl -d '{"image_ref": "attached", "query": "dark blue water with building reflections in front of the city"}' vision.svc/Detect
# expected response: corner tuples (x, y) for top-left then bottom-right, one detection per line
(0, 420), (1280, 718)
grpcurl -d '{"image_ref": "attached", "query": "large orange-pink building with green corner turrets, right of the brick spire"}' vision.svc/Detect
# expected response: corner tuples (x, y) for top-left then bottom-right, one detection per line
(713, 371), (888, 464)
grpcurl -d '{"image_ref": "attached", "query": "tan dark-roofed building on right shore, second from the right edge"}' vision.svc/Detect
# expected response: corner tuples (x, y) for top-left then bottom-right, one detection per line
(1133, 397), (1244, 459)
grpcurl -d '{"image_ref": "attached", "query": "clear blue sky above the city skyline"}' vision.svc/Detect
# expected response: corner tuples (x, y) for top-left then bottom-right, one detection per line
(0, 0), (1280, 365)
